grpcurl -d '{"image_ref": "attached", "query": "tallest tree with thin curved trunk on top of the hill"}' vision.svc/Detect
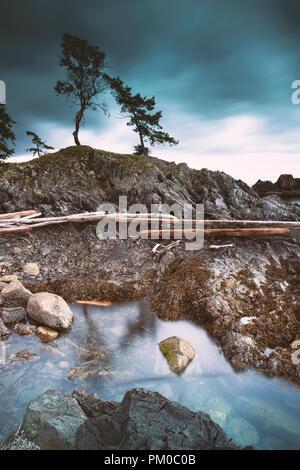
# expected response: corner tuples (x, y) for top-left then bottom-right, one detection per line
(54, 33), (107, 145)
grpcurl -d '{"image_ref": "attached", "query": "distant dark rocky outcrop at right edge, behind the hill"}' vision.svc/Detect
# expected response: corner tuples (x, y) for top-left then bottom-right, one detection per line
(252, 175), (300, 197)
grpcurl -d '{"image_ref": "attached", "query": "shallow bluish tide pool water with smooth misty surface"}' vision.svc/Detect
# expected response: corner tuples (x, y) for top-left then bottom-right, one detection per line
(0, 302), (300, 449)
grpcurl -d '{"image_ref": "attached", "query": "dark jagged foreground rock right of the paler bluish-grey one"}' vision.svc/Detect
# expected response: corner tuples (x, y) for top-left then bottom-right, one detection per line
(76, 389), (237, 450)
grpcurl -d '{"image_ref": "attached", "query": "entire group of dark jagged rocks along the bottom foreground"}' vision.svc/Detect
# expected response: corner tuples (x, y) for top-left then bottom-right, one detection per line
(2, 389), (238, 450)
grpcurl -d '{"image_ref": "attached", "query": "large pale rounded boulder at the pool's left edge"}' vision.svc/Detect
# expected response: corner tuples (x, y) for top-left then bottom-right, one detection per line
(27, 292), (74, 331)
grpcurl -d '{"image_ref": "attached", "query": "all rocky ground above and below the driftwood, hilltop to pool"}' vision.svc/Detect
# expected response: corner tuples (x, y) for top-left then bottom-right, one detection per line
(0, 147), (300, 383)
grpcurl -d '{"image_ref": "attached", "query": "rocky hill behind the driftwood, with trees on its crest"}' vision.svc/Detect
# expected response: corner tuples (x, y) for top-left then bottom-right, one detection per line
(0, 147), (300, 220)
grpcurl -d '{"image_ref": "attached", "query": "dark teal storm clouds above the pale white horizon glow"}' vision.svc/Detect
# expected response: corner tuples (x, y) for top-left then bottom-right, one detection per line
(0, 0), (300, 152)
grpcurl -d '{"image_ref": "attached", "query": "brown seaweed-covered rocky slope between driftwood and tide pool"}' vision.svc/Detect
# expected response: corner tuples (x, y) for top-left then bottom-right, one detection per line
(0, 224), (300, 383)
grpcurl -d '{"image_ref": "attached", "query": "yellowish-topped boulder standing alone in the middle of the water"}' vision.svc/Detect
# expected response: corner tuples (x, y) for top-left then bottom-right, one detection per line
(159, 336), (195, 374)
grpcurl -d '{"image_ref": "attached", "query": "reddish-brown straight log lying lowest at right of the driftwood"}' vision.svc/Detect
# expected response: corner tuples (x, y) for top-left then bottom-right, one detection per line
(140, 228), (290, 238)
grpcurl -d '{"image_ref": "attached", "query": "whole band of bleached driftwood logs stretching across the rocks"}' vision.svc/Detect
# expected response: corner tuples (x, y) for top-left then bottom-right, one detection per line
(0, 210), (300, 238)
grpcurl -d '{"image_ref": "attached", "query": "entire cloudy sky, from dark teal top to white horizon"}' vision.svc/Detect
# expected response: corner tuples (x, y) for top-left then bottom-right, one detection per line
(0, 0), (300, 185)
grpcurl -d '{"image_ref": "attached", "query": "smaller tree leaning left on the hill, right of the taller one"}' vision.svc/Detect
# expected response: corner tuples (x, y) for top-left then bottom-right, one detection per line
(104, 74), (178, 155)
